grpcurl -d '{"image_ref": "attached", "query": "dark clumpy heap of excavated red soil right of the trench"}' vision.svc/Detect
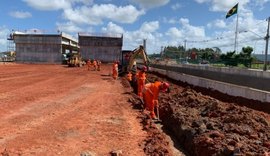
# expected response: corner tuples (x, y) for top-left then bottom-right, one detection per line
(121, 73), (270, 156)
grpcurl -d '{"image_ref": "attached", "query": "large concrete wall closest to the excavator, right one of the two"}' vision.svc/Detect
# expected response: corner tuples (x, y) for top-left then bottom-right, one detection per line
(79, 35), (123, 62)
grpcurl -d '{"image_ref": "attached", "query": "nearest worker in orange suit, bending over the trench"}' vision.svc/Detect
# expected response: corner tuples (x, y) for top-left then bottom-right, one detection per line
(142, 81), (170, 119)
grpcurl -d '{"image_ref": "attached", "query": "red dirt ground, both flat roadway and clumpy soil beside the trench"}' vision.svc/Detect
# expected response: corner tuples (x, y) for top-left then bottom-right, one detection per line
(3, 63), (270, 156)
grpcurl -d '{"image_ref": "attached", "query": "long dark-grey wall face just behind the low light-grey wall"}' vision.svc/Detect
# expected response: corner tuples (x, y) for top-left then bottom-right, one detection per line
(151, 64), (270, 91)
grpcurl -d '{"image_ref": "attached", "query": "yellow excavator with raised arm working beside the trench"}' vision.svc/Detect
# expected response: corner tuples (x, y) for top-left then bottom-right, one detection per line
(119, 45), (150, 74)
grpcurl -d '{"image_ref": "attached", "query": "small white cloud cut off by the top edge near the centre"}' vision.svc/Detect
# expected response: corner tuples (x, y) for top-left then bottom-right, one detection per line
(132, 0), (170, 9)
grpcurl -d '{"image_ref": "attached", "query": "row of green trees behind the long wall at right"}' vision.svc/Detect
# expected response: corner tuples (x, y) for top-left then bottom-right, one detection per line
(149, 46), (255, 67)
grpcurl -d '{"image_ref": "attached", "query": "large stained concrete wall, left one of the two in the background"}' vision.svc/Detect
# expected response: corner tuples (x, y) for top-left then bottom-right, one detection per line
(14, 34), (62, 63)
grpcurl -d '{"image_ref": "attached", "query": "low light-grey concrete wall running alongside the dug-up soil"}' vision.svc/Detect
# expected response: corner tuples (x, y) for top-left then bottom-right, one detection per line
(151, 67), (270, 102)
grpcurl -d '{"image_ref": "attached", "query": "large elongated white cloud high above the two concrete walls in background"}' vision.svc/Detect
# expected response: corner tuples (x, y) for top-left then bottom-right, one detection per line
(63, 4), (145, 25)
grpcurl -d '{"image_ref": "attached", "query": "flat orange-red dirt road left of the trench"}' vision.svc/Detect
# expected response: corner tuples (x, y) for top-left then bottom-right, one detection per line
(0, 64), (150, 156)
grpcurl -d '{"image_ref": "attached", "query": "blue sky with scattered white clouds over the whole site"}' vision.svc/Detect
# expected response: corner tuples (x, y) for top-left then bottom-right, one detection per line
(0, 0), (270, 54)
